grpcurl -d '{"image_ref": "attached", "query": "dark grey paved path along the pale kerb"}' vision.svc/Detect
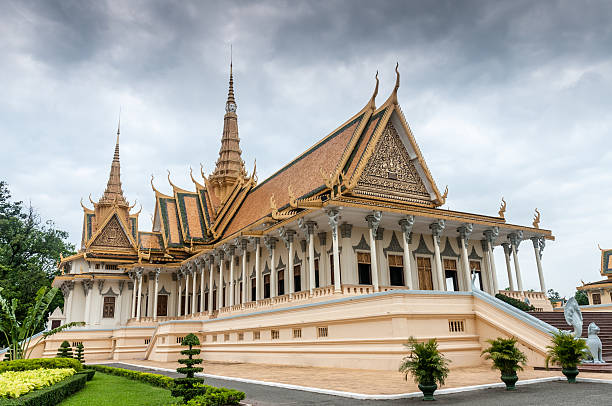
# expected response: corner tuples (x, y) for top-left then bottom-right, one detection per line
(105, 363), (612, 406)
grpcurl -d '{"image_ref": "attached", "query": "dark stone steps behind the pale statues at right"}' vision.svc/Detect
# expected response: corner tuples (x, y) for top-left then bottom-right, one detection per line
(530, 312), (612, 362)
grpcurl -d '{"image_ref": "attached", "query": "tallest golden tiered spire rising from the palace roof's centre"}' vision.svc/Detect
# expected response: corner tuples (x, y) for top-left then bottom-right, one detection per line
(208, 60), (246, 200)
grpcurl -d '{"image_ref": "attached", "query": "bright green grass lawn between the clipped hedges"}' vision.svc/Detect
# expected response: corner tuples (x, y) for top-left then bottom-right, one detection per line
(60, 372), (176, 406)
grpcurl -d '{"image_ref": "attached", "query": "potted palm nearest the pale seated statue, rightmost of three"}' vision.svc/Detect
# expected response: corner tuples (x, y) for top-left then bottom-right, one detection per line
(546, 330), (587, 383)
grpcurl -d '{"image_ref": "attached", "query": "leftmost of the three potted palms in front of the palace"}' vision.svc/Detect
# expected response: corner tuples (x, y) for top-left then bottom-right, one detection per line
(399, 337), (450, 400)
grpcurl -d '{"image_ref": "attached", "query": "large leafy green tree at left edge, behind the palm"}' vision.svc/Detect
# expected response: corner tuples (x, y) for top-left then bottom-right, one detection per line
(0, 181), (74, 347)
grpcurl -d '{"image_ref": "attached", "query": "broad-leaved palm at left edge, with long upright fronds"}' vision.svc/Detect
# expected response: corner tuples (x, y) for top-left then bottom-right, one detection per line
(0, 287), (85, 360)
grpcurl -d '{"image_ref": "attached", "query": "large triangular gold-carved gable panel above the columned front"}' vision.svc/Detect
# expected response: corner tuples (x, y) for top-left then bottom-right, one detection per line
(354, 121), (431, 203)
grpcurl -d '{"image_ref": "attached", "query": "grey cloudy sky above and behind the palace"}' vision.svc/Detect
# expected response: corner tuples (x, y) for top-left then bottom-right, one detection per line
(0, 0), (612, 294)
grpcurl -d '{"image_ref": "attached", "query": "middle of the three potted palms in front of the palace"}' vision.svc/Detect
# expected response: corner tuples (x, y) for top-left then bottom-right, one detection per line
(482, 337), (527, 390)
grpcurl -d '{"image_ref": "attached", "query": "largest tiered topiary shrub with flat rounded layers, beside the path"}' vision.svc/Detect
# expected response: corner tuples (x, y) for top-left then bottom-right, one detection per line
(172, 334), (206, 402)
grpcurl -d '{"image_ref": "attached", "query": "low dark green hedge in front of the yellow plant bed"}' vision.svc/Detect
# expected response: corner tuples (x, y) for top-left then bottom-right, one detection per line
(0, 374), (87, 406)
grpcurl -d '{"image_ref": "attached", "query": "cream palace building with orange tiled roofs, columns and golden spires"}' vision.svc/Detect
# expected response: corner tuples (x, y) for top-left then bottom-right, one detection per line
(36, 64), (554, 370)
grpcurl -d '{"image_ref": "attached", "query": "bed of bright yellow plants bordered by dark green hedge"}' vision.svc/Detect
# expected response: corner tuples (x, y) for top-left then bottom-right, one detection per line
(0, 368), (76, 398)
